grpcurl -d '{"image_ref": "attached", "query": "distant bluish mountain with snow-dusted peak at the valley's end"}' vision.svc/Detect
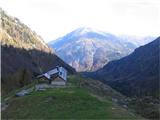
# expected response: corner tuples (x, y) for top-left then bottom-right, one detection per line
(49, 28), (136, 72)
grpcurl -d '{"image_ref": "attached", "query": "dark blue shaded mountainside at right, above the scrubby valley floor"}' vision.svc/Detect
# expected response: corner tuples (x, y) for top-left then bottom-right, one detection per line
(92, 38), (160, 97)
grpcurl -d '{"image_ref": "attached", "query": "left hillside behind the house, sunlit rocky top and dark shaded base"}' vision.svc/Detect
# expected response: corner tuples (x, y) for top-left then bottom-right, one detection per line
(0, 9), (75, 95)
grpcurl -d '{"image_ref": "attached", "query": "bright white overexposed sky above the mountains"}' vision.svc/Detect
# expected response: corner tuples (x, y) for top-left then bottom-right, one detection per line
(0, 0), (160, 42)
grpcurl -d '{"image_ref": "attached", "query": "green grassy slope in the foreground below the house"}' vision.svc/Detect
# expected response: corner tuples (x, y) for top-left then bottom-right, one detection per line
(2, 76), (143, 119)
